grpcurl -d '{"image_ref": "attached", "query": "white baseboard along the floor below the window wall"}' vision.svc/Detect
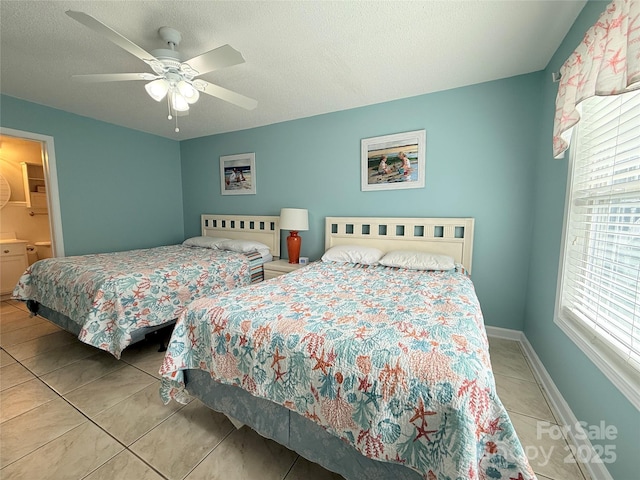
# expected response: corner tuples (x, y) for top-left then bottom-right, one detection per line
(485, 326), (613, 480)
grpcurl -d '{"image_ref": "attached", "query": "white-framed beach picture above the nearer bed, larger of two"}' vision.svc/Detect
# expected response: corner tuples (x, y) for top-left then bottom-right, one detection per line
(360, 130), (427, 192)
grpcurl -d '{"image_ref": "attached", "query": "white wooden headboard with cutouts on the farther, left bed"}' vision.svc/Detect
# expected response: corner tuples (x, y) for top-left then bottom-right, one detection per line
(201, 214), (280, 257)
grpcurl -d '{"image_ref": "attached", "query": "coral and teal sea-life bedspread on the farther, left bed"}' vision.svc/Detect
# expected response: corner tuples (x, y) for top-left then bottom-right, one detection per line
(13, 245), (262, 358)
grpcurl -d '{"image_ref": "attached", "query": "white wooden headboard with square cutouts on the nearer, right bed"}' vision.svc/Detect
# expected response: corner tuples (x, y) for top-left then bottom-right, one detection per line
(324, 217), (474, 273)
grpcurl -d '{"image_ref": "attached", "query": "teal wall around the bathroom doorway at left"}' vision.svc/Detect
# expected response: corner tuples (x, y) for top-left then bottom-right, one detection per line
(0, 95), (184, 255)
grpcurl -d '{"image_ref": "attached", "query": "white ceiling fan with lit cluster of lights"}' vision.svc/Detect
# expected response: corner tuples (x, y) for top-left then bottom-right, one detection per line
(66, 10), (258, 132)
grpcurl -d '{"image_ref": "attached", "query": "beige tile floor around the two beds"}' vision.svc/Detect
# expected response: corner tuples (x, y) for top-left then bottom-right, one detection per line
(0, 300), (590, 480)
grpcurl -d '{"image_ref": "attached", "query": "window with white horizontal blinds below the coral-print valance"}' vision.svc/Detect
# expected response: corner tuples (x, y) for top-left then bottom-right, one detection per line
(556, 91), (640, 408)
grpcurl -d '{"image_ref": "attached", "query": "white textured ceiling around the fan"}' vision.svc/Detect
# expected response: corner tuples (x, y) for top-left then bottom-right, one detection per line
(0, 0), (586, 140)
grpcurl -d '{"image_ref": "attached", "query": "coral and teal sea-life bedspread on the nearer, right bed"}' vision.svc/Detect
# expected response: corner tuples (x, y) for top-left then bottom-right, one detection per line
(160, 262), (535, 480)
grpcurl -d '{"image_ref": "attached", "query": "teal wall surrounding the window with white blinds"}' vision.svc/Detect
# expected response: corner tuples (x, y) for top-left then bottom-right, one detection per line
(524, 2), (640, 480)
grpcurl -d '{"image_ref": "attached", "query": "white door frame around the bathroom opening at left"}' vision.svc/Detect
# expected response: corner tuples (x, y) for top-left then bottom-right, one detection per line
(0, 127), (64, 257)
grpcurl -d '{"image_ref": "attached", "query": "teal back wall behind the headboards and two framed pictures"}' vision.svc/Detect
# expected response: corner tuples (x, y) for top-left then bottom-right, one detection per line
(180, 74), (541, 330)
